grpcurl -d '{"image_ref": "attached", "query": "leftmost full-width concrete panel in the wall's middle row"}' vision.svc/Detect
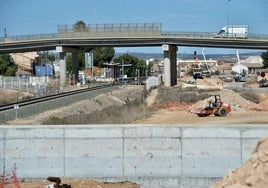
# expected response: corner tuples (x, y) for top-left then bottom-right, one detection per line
(5, 139), (64, 160)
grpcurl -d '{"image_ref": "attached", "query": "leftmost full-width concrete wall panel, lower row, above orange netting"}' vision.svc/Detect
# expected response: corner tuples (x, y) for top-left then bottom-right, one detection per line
(6, 158), (64, 179)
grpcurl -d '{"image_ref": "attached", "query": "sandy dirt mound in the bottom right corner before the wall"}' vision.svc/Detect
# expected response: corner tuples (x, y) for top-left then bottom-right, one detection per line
(212, 139), (268, 188)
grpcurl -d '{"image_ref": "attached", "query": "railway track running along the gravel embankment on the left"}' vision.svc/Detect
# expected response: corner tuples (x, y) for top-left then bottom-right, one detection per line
(0, 84), (111, 112)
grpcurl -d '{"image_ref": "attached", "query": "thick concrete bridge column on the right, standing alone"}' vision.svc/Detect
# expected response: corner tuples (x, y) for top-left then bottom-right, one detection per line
(162, 44), (178, 87)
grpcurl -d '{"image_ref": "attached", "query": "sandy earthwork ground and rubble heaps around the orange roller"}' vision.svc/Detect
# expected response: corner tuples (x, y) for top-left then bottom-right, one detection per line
(133, 78), (268, 126)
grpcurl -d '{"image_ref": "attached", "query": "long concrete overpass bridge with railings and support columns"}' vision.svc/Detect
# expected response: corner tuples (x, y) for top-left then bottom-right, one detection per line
(0, 23), (268, 86)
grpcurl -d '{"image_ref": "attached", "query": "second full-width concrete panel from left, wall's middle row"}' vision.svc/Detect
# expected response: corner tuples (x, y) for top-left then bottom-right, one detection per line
(65, 138), (123, 159)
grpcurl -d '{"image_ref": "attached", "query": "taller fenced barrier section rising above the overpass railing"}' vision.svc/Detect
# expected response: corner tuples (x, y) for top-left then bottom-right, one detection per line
(58, 23), (162, 38)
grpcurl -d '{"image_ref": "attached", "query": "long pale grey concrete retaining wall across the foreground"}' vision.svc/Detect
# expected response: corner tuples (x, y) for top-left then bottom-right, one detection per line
(0, 125), (268, 188)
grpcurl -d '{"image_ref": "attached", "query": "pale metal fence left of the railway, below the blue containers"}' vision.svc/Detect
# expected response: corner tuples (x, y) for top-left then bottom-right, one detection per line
(0, 76), (59, 96)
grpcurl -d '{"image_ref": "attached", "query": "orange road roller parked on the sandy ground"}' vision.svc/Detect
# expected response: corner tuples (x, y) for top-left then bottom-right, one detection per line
(194, 94), (231, 117)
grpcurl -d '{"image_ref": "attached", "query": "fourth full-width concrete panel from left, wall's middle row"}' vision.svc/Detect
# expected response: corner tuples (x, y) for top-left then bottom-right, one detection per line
(182, 138), (241, 158)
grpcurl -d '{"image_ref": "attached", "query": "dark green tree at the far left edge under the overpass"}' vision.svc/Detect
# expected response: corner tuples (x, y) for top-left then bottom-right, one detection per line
(0, 54), (18, 76)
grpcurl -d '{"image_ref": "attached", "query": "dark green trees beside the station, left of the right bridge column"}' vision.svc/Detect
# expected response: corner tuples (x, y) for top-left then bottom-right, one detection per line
(114, 54), (149, 77)
